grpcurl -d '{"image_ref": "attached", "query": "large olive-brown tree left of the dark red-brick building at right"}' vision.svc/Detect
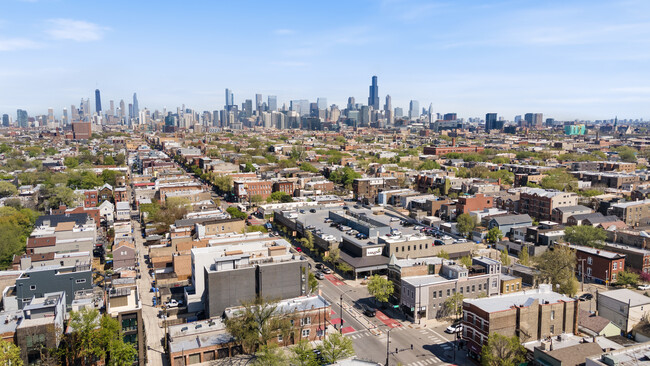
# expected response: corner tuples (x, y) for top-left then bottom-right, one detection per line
(535, 245), (578, 296)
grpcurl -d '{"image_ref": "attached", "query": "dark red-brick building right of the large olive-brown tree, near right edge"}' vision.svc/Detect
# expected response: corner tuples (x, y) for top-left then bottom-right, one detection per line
(569, 245), (625, 283)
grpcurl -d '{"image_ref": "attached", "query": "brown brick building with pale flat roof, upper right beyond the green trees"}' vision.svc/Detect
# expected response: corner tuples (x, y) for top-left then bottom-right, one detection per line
(519, 188), (578, 220)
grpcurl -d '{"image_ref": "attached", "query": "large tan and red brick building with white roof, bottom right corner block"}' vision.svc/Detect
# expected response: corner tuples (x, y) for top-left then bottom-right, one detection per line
(462, 284), (578, 357)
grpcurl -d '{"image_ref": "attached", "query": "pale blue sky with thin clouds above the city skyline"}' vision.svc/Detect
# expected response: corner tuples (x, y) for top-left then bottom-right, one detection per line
(0, 0), (650, 120)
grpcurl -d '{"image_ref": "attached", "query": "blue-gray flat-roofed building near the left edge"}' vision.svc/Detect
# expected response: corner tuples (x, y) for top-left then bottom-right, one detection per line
(16, 265), (93, 309)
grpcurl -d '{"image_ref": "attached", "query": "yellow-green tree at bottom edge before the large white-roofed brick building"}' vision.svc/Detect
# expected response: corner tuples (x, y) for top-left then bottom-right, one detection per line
(481, 333), (526, 366)
